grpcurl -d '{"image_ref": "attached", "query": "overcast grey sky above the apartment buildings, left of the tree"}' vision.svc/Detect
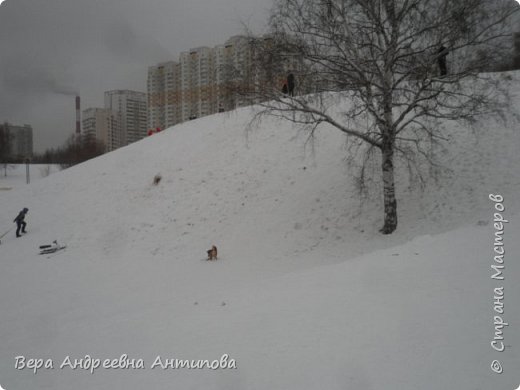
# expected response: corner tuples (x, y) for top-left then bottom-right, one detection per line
(0, 0), (272, 151)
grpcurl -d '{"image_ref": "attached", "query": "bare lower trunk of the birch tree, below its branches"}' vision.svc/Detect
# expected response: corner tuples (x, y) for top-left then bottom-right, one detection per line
(380, 142), (397, 234)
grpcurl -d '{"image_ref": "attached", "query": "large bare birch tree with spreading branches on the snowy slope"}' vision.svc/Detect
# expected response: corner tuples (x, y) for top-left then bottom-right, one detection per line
(249, 0), (518, 234)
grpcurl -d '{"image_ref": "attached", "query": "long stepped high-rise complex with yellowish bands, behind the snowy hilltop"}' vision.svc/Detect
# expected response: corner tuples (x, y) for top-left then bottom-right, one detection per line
(148, 35), (296, 129)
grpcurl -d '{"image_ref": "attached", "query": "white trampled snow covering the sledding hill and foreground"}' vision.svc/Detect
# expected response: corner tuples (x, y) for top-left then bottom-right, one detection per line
(0, 73), (520, 390)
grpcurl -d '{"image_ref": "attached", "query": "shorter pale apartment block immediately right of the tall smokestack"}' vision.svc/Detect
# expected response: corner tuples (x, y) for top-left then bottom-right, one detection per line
(82, 108), (121, 152)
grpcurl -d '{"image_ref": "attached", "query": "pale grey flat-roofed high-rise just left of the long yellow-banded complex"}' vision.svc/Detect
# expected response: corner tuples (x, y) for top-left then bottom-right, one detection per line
(105, 90), (148, 147)
